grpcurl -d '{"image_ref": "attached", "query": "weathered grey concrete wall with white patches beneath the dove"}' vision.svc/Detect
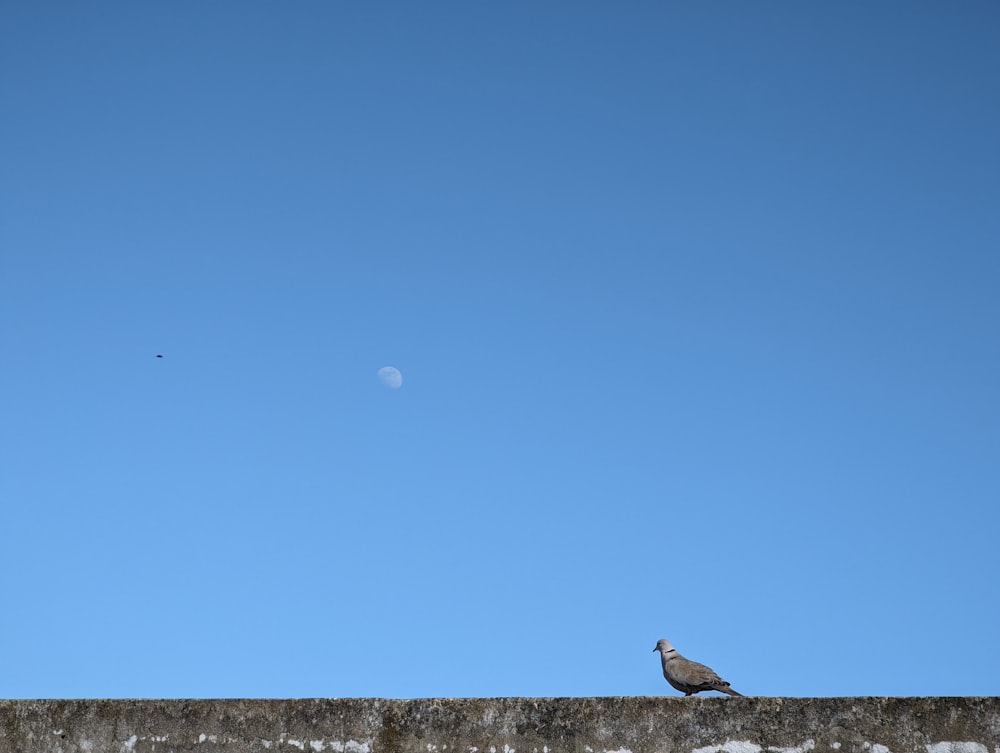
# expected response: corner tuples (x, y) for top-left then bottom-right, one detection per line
(0, 697), (1000, 753)
